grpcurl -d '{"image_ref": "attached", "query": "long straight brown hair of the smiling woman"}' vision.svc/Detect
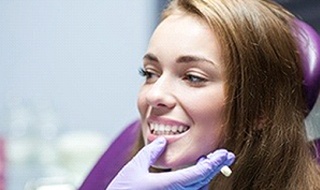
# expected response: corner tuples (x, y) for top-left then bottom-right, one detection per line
(134, 0), (320, 190)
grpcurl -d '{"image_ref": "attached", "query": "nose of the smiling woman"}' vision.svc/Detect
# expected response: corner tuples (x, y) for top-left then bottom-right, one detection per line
(146, 75), (176, 109)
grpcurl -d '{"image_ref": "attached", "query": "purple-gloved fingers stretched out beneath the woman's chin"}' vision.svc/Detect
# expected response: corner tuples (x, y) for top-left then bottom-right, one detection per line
(168, 149), (234, 189)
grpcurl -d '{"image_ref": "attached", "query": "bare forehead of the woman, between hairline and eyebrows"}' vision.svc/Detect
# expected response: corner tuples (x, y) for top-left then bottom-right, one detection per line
(148, 13), (220, 65)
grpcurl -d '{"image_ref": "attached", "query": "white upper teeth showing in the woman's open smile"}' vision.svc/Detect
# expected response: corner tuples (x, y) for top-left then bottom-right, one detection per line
(149, 123), (190, 135)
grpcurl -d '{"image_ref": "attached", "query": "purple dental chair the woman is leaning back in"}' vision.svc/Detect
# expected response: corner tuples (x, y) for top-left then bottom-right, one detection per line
(79, 21), (320, 190)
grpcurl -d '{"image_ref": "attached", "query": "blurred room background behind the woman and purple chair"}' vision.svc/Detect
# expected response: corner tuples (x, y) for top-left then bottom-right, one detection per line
(0, 0), (320, 190)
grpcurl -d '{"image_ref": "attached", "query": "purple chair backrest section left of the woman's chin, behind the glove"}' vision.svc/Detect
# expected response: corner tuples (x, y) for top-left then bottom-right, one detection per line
(79, 120), (140, 190)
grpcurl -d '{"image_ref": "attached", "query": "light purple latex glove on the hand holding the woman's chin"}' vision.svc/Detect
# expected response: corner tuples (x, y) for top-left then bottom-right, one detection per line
(107, 137), (235, 190)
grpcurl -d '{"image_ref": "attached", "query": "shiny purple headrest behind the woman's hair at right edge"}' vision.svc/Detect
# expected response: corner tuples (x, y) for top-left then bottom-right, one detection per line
(296, 20), (320, 113)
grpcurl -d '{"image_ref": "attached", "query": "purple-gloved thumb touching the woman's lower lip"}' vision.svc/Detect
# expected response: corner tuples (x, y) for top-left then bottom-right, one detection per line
(132, 136), (167, 169)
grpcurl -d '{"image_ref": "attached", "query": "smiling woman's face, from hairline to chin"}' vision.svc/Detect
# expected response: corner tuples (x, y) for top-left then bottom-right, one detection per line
(138, 14), (225, 169)
